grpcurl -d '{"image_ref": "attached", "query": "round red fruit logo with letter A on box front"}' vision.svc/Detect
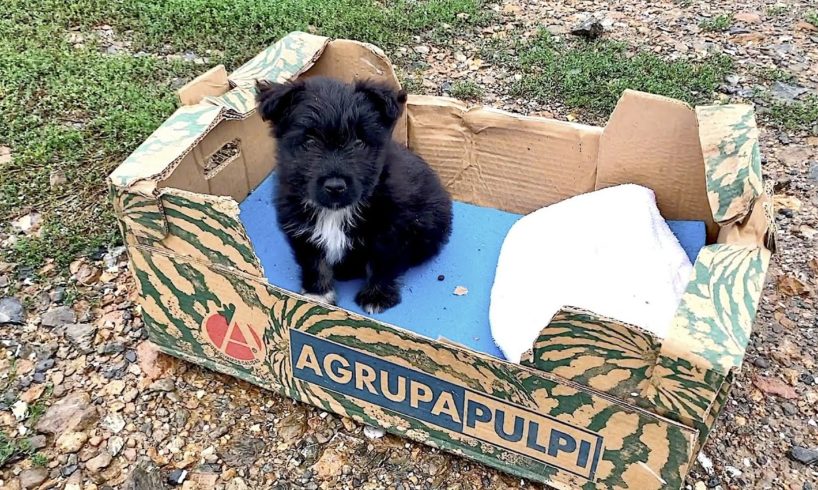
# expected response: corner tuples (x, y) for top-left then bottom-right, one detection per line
(204, 305), (264, 363)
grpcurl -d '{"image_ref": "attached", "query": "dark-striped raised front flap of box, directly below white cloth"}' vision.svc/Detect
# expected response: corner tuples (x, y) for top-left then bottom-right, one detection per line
(530, 307), (661, 403)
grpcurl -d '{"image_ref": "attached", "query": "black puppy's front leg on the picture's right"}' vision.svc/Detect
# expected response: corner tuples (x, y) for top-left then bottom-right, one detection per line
(355, 240), (407, 315)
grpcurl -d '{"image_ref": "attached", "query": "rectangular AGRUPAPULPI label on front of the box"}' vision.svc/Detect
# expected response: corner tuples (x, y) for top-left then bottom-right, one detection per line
(290, 329), (603, 480)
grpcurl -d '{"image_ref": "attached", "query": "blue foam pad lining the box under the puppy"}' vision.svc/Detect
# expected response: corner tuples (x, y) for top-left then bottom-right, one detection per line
(240, 174), (704, 359)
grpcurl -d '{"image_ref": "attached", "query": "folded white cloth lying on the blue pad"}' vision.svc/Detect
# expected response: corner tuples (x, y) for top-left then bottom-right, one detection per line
(489, 184), (692, 362)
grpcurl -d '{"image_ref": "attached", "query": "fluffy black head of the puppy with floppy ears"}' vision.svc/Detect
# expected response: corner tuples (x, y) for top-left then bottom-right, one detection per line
(257, 77), (406, 209)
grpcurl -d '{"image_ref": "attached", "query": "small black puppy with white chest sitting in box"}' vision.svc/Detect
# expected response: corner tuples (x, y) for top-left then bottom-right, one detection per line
(257, 77), (452, 314)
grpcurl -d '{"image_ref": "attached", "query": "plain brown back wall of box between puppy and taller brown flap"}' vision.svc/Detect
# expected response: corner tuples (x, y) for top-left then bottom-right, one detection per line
(409, 97), (600, 213)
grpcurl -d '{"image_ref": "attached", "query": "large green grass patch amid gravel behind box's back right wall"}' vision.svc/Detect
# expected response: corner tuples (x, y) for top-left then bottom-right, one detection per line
(501, 31), (732, 116)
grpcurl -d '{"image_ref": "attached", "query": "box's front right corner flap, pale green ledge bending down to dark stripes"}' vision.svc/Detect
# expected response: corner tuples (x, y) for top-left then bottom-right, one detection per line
(645, 245), (770, 423)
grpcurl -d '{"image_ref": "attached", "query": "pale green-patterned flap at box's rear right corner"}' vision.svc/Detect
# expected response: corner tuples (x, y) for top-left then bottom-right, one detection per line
(696, 105), (764, 226)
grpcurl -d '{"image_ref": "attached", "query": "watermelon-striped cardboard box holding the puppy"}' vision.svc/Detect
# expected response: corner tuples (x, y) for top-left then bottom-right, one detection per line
(110, 33), (773, 489)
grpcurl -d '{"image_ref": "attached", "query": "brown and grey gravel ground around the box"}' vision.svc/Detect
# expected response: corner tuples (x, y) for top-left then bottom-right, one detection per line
(0, 0), (818, 490)
